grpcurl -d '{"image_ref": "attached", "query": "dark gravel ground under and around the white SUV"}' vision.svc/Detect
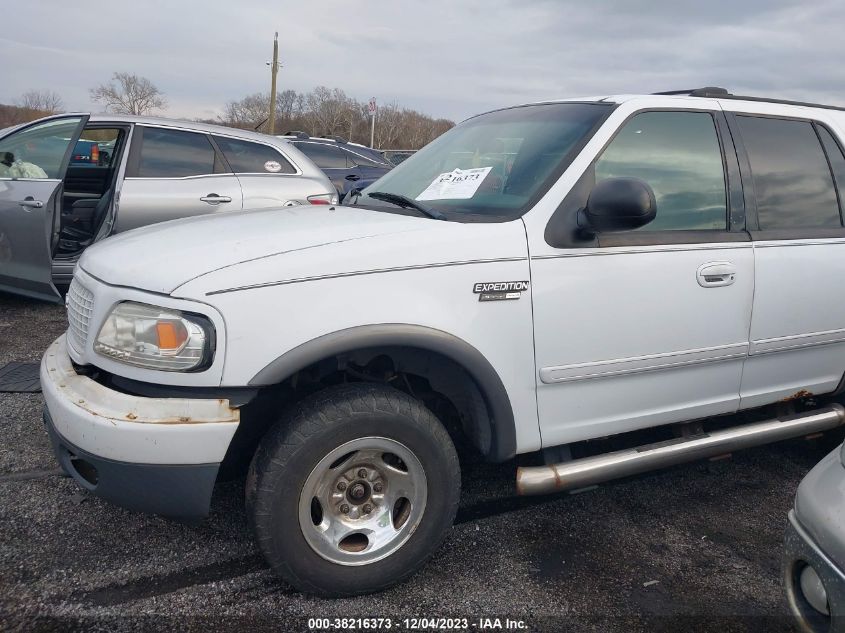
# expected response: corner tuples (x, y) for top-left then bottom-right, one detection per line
(0, 294), (836, 631)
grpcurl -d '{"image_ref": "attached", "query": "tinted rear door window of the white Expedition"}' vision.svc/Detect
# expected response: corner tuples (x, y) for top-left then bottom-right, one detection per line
(736, 115), (842, 230)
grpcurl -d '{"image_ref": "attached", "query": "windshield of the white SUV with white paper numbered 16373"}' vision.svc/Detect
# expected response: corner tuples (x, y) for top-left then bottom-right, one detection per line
(357, 103), (612, 221)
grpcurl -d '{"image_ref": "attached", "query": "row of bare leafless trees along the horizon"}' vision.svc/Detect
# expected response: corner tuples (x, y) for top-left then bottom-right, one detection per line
(0, 73), (455, 149)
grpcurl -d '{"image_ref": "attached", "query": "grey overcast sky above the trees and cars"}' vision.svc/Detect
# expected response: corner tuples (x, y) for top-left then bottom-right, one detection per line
(0, 0), (845, 120)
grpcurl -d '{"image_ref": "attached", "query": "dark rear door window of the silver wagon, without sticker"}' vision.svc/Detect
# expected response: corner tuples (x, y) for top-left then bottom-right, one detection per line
(138, 127), (220, 178)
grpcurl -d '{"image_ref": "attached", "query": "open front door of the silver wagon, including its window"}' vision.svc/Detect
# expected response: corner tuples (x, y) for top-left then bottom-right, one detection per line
(0, 114), (88, 301)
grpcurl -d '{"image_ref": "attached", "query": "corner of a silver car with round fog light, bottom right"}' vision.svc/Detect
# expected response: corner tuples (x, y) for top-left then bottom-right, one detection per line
(784, 446), (845, 633)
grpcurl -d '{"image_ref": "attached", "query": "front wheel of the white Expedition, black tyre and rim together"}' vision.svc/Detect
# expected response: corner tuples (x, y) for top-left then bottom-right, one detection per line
(247, 383), (460, 596)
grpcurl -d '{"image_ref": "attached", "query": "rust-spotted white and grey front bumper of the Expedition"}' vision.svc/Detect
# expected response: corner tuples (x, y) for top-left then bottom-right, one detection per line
(41, 336), (240, 517)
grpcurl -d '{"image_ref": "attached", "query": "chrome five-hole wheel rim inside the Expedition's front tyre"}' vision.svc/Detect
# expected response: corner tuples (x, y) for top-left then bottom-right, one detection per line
(299, 437), (428, 565)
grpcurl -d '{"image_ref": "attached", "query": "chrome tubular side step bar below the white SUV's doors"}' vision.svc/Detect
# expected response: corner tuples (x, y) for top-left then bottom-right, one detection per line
(516, 404), (845, 495)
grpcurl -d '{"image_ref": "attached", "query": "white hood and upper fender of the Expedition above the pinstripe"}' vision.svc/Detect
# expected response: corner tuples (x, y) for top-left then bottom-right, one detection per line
(79, 206), (526, 297)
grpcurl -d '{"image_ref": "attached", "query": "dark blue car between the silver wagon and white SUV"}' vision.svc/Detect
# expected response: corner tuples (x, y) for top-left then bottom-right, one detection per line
(280, 132), (393, 200)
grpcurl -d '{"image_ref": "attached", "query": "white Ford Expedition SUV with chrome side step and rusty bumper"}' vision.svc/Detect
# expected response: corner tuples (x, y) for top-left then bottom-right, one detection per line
(41, 88), (845, 596)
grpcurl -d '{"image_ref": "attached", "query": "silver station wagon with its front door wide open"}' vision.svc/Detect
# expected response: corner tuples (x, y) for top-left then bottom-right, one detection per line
(0, 114), (337, 300)
